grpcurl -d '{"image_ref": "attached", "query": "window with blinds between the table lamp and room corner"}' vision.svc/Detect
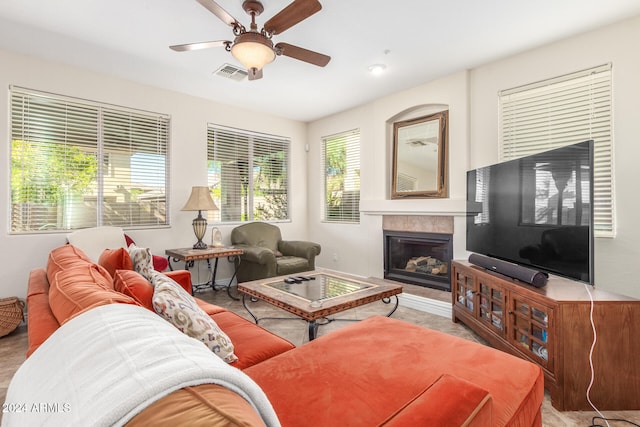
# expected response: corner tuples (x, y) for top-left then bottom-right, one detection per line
(207, 124), (289, 222)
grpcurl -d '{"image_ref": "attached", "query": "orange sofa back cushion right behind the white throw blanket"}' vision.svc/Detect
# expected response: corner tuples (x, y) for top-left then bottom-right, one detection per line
(49, 263), (136, 325)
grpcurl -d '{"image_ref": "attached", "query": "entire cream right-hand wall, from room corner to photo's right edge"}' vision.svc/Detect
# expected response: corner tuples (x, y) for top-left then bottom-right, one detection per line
(308, 18), (640, 298)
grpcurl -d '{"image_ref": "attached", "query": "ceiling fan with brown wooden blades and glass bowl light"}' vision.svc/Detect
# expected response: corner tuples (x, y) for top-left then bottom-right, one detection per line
(169, 0), (331, 80)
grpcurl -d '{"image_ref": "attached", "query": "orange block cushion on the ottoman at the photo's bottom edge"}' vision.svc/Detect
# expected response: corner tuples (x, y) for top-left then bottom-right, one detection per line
(381, 374), (493, 427)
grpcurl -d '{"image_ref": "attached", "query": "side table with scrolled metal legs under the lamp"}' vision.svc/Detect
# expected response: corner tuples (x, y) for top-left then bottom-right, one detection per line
(164, 246), (243, 301)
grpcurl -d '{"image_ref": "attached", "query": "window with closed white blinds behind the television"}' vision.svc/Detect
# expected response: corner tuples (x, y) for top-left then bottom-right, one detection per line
(499, 64), (615, 237)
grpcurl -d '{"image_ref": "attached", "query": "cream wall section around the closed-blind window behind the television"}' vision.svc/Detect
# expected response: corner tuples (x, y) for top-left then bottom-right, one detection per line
(470, 17), (640, 298)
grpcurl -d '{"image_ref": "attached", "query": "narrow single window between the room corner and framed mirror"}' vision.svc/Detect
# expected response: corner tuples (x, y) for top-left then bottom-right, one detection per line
(322, 130), (360, 223)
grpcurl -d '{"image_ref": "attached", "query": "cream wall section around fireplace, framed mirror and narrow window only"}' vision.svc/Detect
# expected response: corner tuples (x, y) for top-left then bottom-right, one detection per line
(308, 72), (468, 277)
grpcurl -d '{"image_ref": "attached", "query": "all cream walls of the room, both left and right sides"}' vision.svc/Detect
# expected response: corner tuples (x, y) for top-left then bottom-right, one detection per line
(0, 17), (640, 298)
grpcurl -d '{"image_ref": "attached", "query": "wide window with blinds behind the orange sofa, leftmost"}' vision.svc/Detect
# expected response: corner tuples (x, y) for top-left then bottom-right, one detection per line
(10, 86), (169, 233)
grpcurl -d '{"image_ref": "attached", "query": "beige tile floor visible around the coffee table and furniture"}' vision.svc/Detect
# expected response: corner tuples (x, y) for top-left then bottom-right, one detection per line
(0, 285), (640, 427)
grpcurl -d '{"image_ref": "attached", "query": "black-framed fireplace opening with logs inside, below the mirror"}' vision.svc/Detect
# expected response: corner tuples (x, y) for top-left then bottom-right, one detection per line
(383, 230), (453, 291)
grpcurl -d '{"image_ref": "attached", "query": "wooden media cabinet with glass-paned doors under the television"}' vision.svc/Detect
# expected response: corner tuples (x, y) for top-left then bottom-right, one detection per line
(451, 261), (640, 411)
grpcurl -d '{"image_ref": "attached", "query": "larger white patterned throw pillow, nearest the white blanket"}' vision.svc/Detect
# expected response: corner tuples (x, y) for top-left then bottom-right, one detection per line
(151, 271), (238, 363)
